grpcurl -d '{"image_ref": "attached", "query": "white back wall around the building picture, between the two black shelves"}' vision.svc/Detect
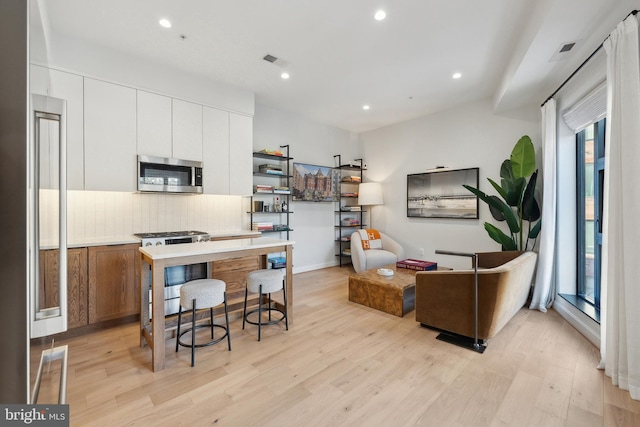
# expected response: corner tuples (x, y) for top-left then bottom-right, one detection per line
(253, 104), (360, 272)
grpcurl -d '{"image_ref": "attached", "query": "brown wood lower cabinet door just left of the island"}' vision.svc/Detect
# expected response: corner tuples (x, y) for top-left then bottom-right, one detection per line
(89, 244), (140, 323)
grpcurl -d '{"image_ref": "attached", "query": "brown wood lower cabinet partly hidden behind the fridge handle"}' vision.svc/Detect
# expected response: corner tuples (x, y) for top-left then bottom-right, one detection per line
(40, 248), (88, 329)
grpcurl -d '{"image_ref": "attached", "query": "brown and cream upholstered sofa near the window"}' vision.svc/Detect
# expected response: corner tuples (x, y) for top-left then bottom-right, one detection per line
(416, 251), (537, 340)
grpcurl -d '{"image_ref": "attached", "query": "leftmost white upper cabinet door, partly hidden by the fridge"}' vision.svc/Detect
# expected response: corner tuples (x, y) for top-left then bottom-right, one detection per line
(29, 65), (84, 190)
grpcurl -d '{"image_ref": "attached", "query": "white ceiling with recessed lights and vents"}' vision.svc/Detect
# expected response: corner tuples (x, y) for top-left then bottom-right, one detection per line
(33, 0), (640, 132)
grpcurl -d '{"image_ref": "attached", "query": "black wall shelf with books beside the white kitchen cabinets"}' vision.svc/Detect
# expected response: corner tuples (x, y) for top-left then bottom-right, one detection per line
(248, 145), (293, 240)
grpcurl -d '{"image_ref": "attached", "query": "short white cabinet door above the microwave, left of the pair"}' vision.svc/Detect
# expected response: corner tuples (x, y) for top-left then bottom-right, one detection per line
(137, 90), (172, 158)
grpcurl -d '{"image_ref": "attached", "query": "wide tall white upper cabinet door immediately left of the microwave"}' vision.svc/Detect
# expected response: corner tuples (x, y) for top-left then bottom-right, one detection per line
(84, 78), (137, 191)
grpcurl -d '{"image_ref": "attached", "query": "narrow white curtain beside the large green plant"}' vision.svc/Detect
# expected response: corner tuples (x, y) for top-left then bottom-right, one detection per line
(529, 98), (557, 312)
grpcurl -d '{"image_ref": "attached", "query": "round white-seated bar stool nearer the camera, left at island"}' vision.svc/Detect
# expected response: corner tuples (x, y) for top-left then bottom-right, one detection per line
(176, 279), (231, 367)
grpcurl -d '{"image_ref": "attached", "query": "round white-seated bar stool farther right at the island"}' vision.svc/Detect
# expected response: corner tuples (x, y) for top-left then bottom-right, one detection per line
(242, 269), (289, 341)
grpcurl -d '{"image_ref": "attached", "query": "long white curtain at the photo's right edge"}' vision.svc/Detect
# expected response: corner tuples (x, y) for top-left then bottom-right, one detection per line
(600, 15), (640, 400)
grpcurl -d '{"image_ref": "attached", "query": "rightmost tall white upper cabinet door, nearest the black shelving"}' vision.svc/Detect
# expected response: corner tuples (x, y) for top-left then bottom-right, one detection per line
(229, 113), (253, 196)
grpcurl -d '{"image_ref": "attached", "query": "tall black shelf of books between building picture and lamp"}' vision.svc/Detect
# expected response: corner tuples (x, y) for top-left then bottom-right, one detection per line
(333, 154), (365, 267)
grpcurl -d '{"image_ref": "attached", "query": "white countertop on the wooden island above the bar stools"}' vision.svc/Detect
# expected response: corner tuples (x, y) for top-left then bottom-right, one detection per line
(139, 237), (295, 260)
